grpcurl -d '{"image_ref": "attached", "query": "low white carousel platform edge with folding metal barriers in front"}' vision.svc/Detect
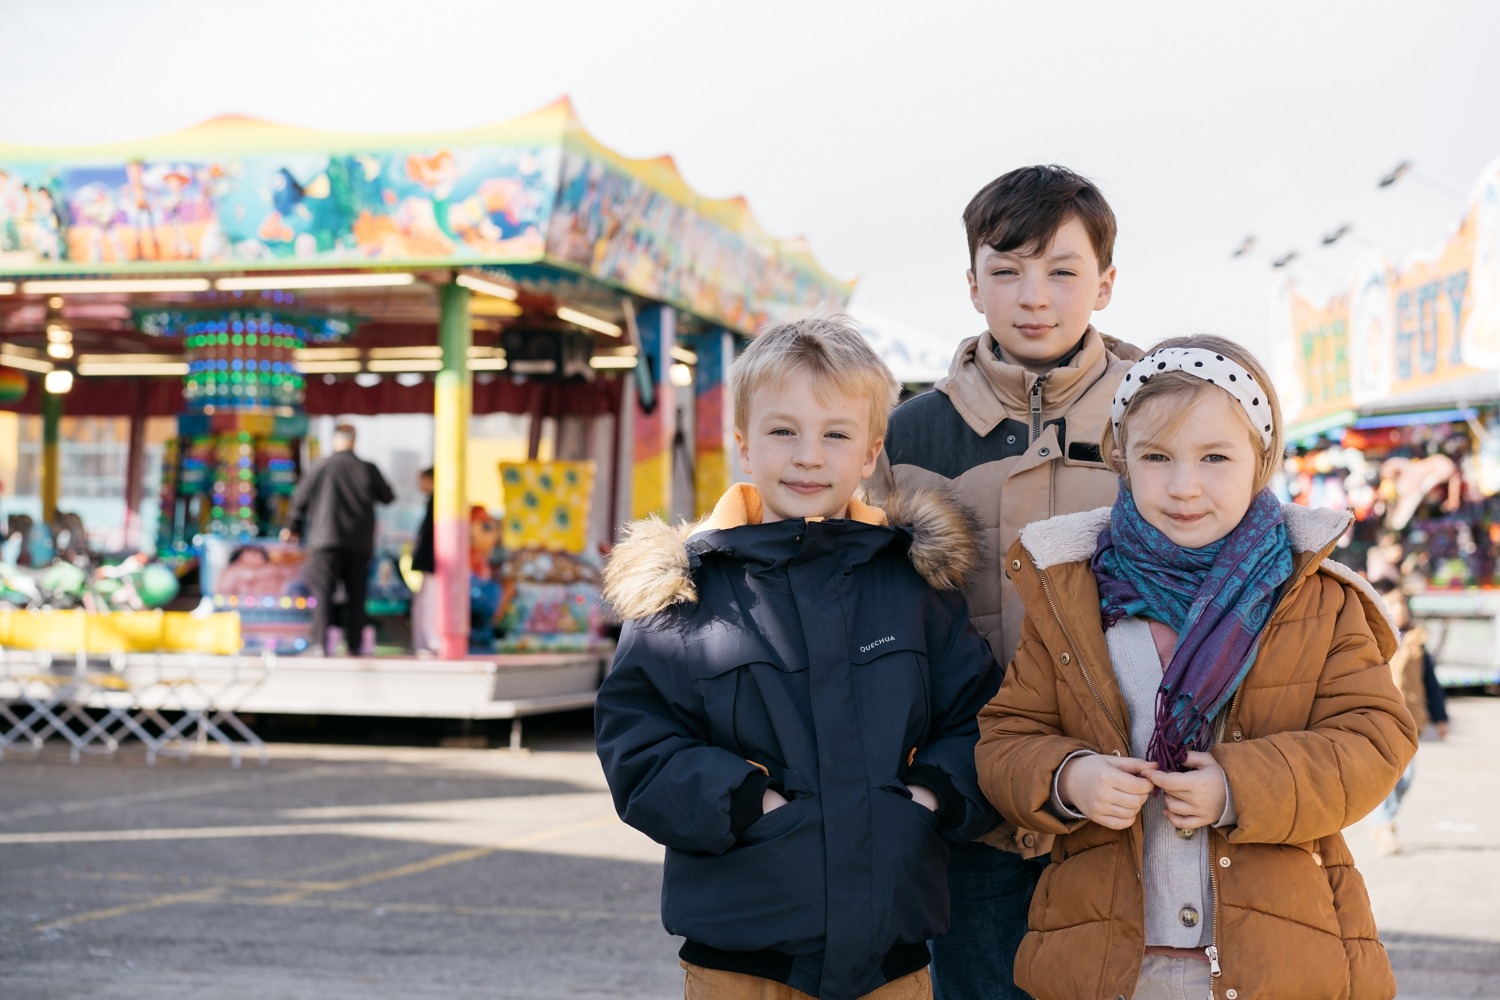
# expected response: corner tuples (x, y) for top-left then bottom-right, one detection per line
(0, 649), (614, 766)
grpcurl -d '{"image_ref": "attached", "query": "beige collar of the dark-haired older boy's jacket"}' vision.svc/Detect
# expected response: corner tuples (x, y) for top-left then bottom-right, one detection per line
(935, 325), (1110, 435)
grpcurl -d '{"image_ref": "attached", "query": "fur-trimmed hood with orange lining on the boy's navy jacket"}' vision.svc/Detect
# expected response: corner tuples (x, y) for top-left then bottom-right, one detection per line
(605, 483), (983, 619)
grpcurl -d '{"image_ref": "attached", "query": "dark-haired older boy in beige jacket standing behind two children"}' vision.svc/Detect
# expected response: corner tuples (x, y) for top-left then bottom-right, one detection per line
(870, 166), (1140, 1000)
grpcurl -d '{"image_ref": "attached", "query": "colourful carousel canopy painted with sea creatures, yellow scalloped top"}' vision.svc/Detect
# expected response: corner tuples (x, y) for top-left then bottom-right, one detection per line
(0, 97), (852, 349)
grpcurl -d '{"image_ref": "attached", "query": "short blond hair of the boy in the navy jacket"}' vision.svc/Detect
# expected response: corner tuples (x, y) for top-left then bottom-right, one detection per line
(729, 315), (902, 441)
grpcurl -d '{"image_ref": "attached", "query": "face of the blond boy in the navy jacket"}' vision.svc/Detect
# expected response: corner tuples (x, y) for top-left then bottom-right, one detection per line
(735, 372), (884, 522)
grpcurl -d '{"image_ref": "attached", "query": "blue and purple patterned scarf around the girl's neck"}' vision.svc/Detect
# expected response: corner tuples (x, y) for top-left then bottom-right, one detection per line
(1091, 481), (1292, 771)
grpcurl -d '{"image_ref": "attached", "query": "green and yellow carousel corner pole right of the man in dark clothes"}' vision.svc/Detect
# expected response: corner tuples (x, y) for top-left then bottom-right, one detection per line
(432, 282), (474, 660)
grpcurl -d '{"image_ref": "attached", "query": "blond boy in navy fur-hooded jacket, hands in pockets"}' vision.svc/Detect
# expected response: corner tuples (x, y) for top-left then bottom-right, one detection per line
(596, 318), (999, 1000)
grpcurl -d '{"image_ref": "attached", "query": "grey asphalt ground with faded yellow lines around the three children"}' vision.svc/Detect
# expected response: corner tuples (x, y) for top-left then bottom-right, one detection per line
(0, 697), (1500, 1000)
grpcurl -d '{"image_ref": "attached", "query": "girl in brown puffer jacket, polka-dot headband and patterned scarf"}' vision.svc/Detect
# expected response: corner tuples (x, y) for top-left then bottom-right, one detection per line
(977, 336), (1416, 1000)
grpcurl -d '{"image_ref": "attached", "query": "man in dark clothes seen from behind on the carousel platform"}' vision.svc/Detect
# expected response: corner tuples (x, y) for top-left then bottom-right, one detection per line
(282, 424), (396, 652)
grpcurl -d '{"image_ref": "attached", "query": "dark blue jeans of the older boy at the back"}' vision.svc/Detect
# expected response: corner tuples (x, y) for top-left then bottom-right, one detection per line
(932, 843), (1047, 1000)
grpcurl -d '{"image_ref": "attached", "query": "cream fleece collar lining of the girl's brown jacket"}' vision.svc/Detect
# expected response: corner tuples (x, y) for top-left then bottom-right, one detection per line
(1022, 504), (1397, 633)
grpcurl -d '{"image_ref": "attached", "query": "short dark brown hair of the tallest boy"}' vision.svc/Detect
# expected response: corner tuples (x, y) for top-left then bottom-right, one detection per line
(963, 165), (1115, 271)
